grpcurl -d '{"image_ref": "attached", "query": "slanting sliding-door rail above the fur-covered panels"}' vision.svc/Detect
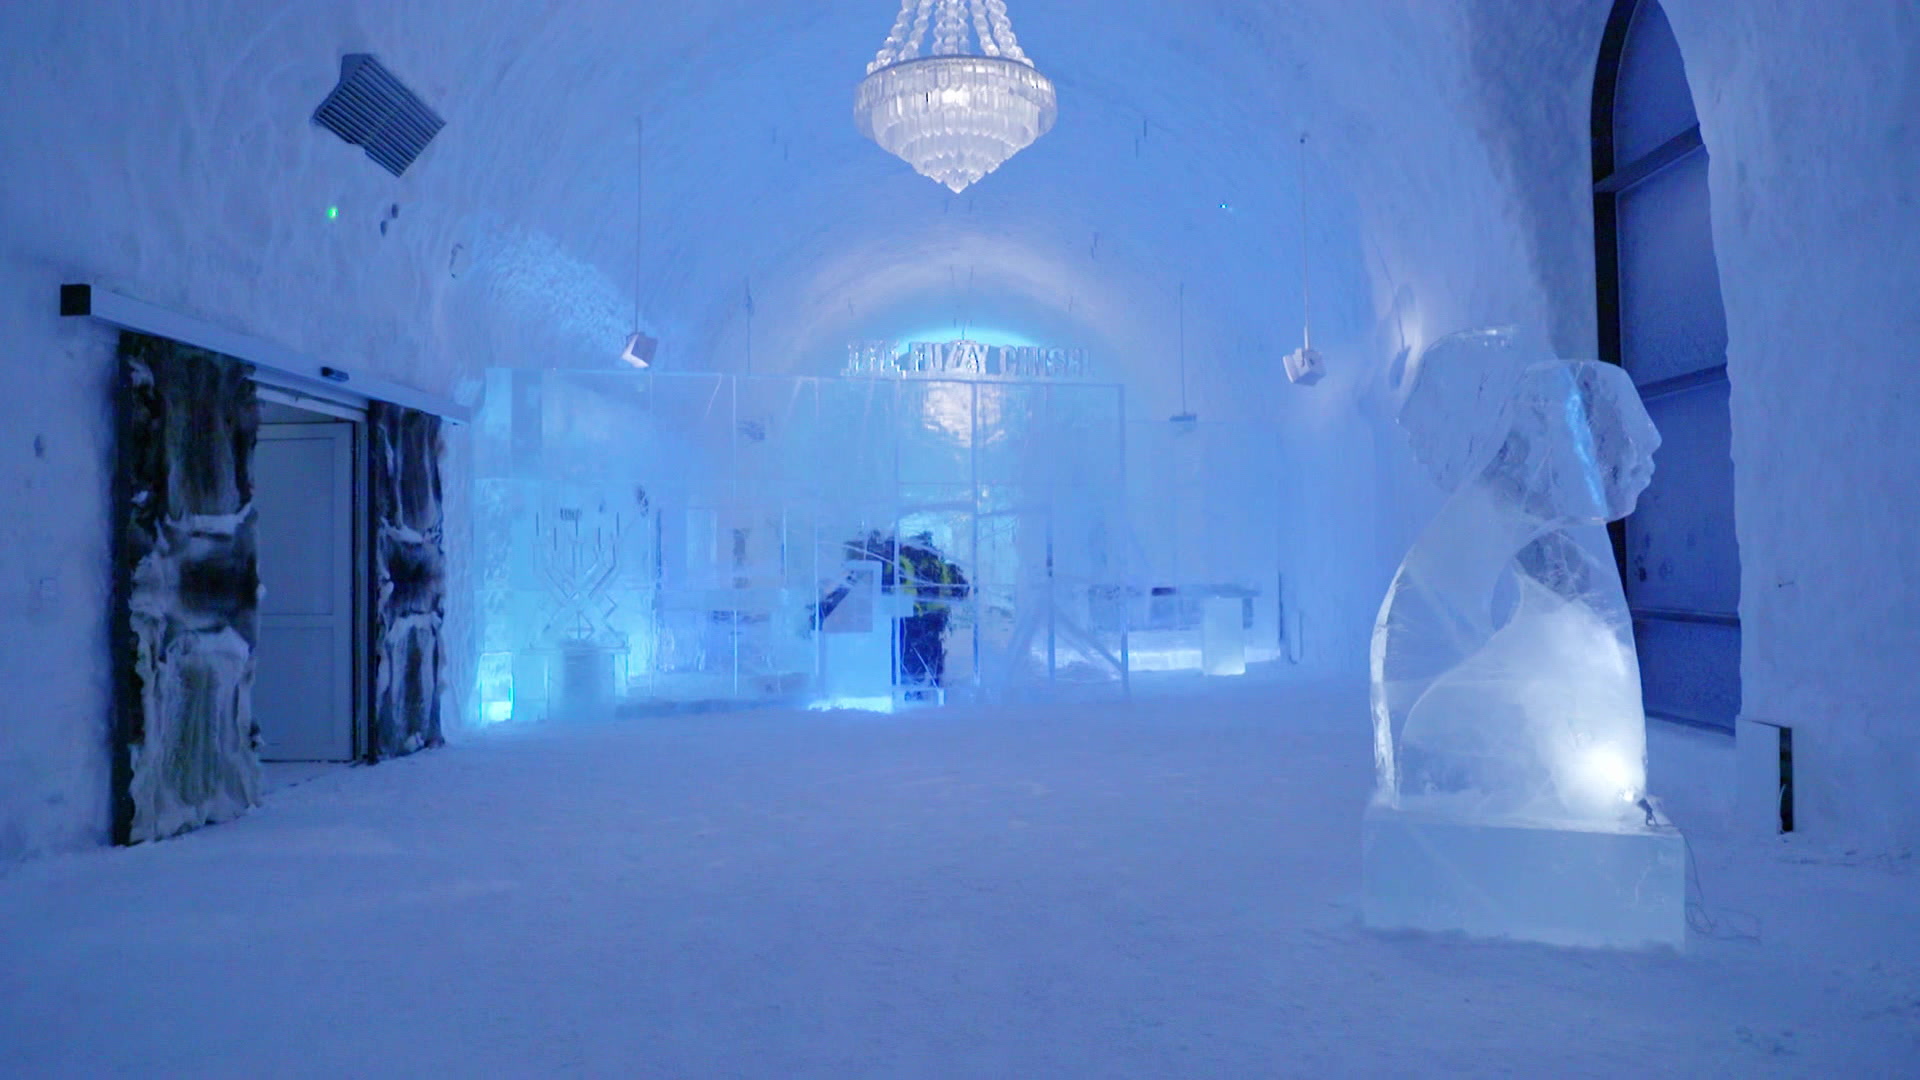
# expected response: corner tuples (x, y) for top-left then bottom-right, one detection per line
(60, 284), (472, 425)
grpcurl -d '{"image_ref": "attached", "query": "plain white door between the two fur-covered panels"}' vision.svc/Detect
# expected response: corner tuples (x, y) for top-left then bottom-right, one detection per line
(253, 423), (353, 761)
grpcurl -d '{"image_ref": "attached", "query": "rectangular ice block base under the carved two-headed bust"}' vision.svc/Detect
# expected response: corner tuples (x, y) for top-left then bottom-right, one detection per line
(1361, 805), (1686, 949)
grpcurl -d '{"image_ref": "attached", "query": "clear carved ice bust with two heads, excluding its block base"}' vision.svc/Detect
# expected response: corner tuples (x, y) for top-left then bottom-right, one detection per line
(1373, 331), (1659, 822)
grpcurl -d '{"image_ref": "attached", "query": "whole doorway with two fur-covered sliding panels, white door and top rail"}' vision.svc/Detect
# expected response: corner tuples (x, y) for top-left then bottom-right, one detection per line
(99, 319), (455, 844)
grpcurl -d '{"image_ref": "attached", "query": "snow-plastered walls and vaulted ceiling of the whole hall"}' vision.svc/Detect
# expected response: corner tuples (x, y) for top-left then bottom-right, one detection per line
(0, 0), (1920, 863)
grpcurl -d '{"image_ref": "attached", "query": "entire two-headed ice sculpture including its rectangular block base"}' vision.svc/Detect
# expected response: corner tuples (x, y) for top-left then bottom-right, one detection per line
(1363, 329), (1684, 945)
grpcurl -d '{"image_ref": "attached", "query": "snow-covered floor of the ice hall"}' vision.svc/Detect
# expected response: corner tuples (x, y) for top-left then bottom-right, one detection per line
(0, 688), (1920, 1078)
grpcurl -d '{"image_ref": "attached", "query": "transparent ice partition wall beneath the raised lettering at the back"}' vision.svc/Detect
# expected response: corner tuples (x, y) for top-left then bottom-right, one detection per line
(474, 369), (1154, 721)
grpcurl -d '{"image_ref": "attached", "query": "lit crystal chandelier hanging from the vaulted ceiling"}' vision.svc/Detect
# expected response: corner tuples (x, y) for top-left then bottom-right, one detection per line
(854, 0), (1058, 194)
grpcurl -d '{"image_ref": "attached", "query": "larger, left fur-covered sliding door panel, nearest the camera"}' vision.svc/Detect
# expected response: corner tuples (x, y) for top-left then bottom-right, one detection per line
(113, 332), (261, 844)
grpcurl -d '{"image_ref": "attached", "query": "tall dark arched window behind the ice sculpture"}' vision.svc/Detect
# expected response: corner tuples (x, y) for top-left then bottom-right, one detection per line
(1594, 0), (1740, 730)
